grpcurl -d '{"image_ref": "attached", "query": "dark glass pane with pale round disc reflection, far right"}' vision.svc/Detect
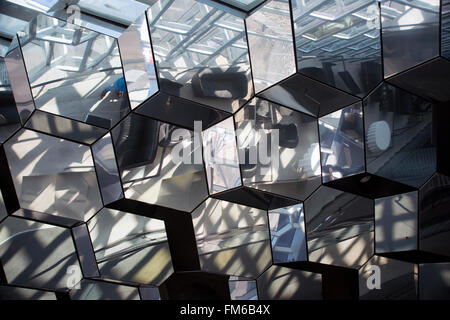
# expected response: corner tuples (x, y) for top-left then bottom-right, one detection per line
(363, 84), (436, 187)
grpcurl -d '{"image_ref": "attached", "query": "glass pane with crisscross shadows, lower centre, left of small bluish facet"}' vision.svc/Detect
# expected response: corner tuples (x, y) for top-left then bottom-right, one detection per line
(192, 198), (272, 278)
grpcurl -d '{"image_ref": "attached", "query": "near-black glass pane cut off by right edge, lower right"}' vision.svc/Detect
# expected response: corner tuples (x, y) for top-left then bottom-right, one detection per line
(419, 174), (450, 256)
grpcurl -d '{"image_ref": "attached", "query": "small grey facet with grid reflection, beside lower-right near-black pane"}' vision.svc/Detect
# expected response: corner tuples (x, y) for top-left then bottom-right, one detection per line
(375, 192), (418, 253)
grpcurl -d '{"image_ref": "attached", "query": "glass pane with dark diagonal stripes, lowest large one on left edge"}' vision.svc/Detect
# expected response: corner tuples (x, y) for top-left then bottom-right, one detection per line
(0, 217), (82, 290)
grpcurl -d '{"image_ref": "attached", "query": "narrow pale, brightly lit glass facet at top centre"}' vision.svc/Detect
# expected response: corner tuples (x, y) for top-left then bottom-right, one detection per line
(246, 0), (296, 92)
